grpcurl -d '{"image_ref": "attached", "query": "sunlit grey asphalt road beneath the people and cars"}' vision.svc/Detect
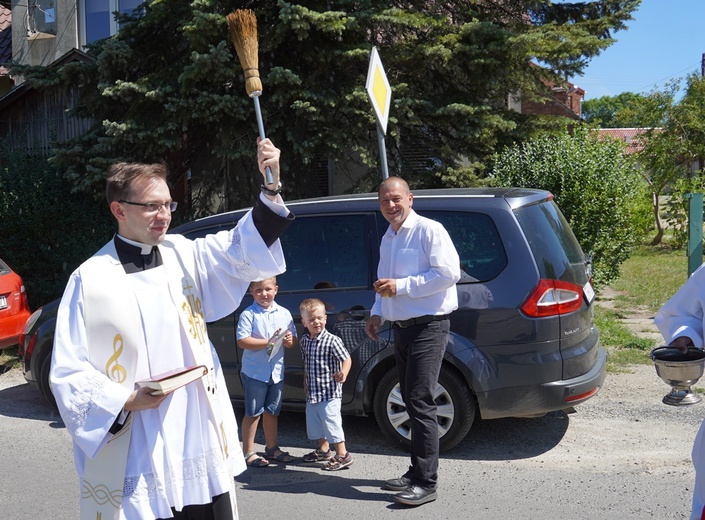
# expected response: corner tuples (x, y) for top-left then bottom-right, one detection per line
(0, 367), (705, 520)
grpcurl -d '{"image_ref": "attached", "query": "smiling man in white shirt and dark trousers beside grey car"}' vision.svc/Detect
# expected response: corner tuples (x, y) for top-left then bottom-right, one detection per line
(365, 177), (460, 506)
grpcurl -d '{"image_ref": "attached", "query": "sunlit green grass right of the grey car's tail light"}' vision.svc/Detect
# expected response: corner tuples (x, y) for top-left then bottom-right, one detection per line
(595, 242), (688, 372)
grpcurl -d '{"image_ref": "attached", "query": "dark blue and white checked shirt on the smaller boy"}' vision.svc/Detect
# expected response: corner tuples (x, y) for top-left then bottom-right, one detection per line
(299, 329), (350, 403)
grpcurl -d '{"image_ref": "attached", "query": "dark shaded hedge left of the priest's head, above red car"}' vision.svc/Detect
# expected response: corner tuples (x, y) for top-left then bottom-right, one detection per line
(0, 149), (116, 310)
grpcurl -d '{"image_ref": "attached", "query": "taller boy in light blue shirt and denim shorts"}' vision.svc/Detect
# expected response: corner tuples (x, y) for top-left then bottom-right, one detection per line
(237, 277), (296, 468)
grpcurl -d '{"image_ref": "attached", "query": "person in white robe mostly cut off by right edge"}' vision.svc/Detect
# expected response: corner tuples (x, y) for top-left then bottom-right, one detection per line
(654, 265), (705, 520)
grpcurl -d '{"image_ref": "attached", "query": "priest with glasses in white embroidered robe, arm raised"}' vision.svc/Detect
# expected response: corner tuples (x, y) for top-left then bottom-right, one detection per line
(50, 139), (294, 520)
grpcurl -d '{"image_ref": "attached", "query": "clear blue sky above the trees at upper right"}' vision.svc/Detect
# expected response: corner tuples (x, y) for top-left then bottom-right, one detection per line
(570, 0), (705, 100)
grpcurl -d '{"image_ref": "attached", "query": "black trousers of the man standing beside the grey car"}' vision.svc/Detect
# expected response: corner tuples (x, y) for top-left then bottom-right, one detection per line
(394, 319), (450, 488)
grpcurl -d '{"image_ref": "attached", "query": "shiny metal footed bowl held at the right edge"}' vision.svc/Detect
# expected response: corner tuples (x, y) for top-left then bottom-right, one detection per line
(651, 347), (705, 406)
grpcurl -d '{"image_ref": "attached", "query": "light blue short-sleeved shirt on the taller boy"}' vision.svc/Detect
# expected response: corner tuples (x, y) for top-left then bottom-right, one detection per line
(236, 302), (296, 383)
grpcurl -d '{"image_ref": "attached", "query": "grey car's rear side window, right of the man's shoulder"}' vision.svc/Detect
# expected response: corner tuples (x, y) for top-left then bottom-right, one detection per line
(422, 211), (507, 283)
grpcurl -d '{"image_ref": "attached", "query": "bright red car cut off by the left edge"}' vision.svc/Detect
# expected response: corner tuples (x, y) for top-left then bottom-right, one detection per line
(0, 259), (30, 349)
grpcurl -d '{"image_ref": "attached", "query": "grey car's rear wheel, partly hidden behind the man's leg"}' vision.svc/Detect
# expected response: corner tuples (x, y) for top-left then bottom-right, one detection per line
(374, 368), (475, 451)
